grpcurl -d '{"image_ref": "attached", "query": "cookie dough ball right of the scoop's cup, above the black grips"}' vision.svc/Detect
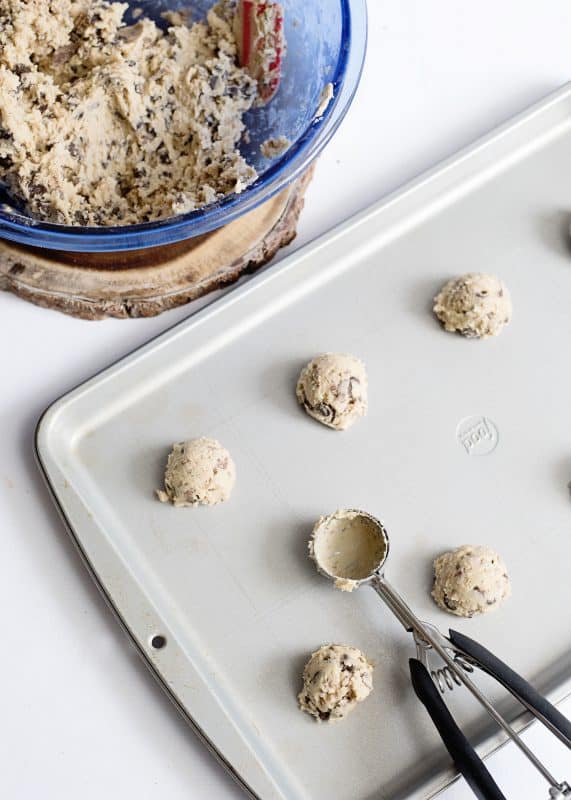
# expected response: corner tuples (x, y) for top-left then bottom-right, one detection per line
(432, 544), (511, 617)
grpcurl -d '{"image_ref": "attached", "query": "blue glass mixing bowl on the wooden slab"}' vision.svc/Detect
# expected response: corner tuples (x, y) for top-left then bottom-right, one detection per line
(0, 0), (367, 253)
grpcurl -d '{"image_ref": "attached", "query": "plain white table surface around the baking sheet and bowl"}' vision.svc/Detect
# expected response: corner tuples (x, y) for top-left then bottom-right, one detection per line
(0, 0), (571, 800)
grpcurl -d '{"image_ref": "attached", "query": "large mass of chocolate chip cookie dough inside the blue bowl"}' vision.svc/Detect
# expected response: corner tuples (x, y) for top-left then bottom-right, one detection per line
(0, 0), (258, 225)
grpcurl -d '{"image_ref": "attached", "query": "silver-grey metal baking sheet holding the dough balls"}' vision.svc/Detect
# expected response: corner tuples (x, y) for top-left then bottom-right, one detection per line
(37, 87), (571, 800)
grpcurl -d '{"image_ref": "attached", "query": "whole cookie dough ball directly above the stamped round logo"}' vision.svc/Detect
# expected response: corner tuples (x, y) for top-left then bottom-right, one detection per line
(434, 272), (512, 339)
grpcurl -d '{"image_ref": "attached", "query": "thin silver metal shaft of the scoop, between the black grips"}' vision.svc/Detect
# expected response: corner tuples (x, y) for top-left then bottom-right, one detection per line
(370, 574), (571, 800)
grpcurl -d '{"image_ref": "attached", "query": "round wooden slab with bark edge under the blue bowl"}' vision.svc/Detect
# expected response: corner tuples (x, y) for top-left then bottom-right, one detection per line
(0, 168), (313, 319)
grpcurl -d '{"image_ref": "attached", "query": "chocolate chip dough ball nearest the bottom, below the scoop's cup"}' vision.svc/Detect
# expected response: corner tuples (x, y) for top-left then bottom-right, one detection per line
(298, 644), (373, 722)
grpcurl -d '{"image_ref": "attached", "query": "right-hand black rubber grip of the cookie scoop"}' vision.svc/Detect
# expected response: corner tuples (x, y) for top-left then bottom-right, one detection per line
(449, 630), (571, 748)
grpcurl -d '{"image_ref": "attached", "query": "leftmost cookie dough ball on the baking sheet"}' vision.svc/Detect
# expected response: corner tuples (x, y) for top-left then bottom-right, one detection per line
(157, 437), (236, 506)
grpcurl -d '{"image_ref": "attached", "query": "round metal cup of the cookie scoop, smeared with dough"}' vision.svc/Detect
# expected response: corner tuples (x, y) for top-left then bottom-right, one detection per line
(308, 509), (387, 592)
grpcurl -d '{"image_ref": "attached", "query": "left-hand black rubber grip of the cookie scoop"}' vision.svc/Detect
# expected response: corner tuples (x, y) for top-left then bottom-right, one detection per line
(408, 658), (506, 800)
